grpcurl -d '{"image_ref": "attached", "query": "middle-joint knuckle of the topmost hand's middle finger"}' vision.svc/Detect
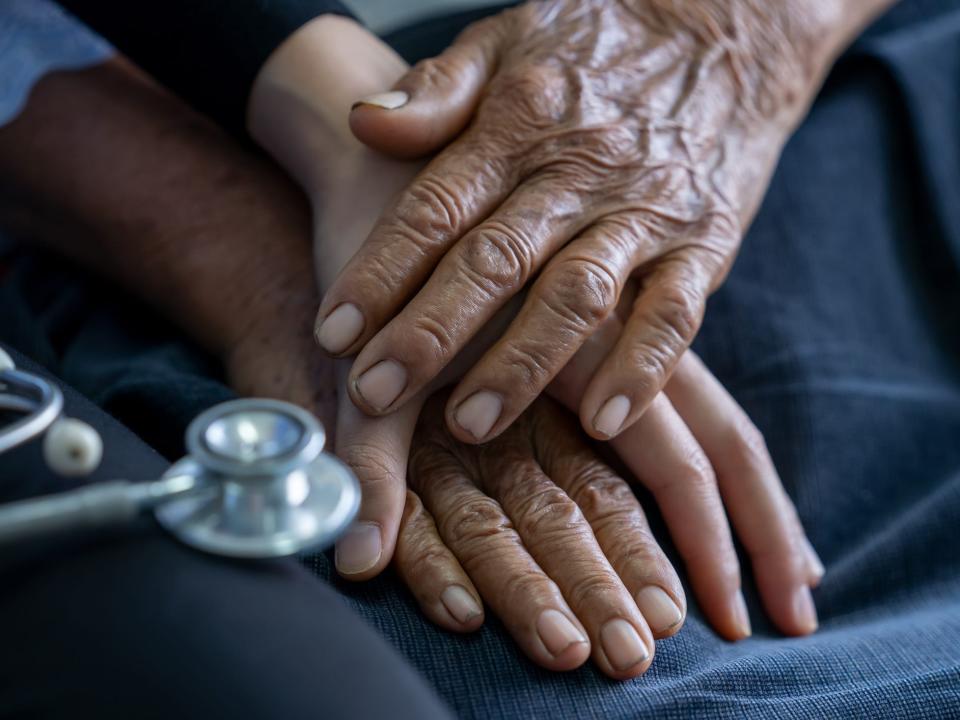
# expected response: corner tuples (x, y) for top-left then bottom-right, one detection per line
(462, 221), (534, 296)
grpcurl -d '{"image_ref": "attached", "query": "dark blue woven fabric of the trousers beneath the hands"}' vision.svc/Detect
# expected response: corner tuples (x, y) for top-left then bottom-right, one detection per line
(0, 0), (960, 718)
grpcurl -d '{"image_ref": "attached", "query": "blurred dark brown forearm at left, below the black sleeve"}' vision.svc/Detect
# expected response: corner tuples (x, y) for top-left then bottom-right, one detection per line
(0, 61), (316, 353)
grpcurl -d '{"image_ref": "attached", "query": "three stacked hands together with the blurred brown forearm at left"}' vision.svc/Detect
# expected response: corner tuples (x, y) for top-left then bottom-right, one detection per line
(0, 0), (889, 678)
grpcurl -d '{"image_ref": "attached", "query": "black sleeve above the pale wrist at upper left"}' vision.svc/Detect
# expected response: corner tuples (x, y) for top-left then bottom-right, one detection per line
(60, 0), (352, 133)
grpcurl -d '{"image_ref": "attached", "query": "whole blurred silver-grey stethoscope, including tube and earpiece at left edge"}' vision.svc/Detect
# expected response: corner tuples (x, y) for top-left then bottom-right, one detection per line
(0, 349), (360, 558)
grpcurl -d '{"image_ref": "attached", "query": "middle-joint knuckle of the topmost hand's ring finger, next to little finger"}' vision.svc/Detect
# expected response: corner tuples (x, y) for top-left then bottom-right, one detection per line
(541, 258), (620, 330)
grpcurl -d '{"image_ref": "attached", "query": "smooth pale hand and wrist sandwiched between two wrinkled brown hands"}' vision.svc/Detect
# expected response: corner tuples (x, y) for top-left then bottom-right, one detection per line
(252, 17), (823, 639)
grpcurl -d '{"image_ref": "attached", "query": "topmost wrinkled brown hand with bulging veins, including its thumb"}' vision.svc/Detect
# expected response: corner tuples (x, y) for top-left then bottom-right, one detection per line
(318, 0), (889, 442)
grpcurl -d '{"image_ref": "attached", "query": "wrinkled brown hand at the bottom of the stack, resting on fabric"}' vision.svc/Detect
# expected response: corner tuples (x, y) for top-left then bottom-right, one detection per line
(394, 396), (672, 678)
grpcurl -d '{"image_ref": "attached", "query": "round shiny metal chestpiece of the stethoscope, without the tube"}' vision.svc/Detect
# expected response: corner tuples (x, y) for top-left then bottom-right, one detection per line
(154, 399), (360, 557)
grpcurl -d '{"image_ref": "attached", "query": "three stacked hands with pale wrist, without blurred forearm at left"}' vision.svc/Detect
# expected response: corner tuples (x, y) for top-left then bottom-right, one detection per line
(240, 0), (848, 678)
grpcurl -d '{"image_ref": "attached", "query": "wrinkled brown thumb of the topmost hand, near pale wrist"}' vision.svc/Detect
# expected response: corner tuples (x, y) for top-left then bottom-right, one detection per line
(350, 17), (502, 159)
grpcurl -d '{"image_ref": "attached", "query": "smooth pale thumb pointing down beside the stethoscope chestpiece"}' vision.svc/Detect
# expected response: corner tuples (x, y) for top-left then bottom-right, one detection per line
(335, 362), (424, 580)
